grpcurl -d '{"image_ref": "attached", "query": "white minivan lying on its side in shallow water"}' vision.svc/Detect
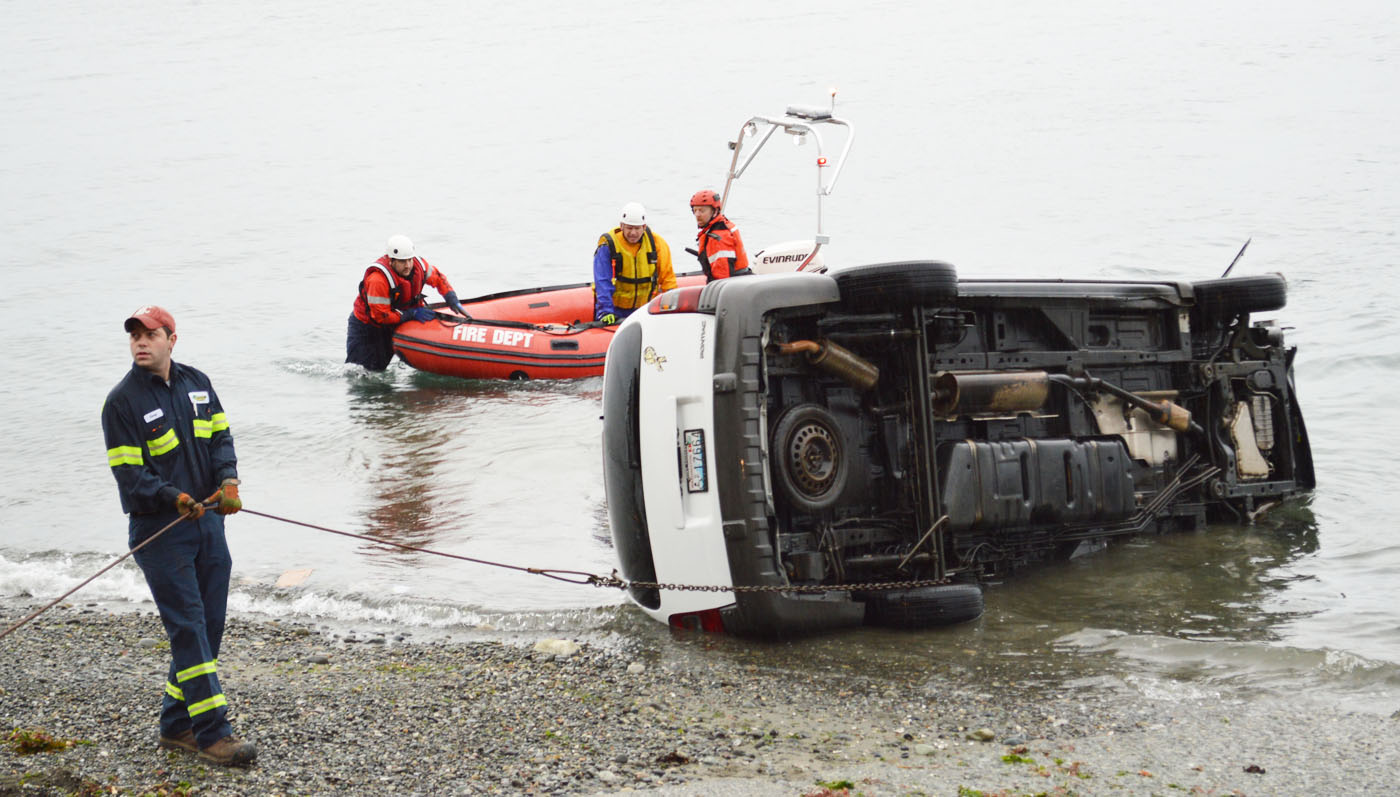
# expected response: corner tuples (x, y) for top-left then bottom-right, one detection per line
(603, 262), (1315, 637)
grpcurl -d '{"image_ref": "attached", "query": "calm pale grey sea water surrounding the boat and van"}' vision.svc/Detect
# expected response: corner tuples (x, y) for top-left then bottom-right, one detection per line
(0, 0), (1400, 710)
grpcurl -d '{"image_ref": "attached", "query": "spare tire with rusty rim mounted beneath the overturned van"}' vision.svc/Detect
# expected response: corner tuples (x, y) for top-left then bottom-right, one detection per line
(771, 403), (851, 513)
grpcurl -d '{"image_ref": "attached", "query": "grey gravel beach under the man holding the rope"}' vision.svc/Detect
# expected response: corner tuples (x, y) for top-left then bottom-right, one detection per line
(0, 605), (1400, 797)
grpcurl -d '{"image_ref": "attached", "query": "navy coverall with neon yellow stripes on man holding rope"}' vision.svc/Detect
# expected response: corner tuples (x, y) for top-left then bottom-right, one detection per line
(102, 361), (238, 748)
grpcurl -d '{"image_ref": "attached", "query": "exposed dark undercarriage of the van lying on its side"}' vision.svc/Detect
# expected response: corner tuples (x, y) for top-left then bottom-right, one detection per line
(760, 263), (1313, 616)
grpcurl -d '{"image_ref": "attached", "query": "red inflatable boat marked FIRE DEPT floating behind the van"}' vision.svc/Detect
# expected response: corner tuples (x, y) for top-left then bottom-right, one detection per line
(393, 273), (704, 380)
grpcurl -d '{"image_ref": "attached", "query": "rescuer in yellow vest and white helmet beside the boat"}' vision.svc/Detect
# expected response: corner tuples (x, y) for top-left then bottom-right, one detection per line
(594, 202), (676, 324)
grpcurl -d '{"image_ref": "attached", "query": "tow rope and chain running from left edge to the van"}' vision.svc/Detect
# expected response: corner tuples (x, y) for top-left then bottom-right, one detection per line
(0, 504), (951, 639)
